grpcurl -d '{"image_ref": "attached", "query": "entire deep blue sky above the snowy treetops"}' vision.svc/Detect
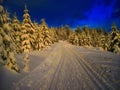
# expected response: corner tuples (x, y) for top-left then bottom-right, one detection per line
(2, 0), (120, 28)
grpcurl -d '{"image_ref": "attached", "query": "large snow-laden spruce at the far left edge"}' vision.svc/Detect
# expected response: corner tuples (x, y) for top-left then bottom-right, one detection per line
(0, 6), (20, 72)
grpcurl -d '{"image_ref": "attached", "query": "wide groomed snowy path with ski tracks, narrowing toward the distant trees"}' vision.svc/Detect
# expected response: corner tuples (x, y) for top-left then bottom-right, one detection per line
(0, 41), (119, 90)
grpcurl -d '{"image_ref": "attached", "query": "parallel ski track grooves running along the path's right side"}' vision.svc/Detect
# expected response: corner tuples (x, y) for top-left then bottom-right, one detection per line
(70, 46), (114, 90)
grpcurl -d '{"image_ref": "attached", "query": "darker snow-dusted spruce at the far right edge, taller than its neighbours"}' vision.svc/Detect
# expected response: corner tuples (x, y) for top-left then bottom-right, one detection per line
(108, 23), (120, 53)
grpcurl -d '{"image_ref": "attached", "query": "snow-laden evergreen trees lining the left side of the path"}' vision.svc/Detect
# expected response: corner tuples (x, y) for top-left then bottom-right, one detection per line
(0, 6), (58, 72)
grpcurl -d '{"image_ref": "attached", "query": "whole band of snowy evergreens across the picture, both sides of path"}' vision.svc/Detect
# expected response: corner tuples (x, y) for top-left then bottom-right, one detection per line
(0, 6), (120, 72)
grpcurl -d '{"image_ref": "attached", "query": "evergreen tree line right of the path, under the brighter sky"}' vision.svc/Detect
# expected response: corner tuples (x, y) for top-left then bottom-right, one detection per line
(57, 23), (120, 53)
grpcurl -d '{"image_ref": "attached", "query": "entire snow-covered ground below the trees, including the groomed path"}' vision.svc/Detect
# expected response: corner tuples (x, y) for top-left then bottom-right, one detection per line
(0, 41), (120, 90)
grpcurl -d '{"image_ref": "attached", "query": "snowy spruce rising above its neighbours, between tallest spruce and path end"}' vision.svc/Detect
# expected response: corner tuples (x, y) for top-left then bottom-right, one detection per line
(40, 19), (52, 47)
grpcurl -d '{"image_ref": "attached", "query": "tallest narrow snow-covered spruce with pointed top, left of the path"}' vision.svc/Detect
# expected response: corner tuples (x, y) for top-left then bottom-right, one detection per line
(21, 5), (34, 72)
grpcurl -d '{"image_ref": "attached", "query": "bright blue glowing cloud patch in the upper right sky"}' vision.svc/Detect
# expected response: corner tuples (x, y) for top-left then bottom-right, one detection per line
(76, 0), (116, 27)
